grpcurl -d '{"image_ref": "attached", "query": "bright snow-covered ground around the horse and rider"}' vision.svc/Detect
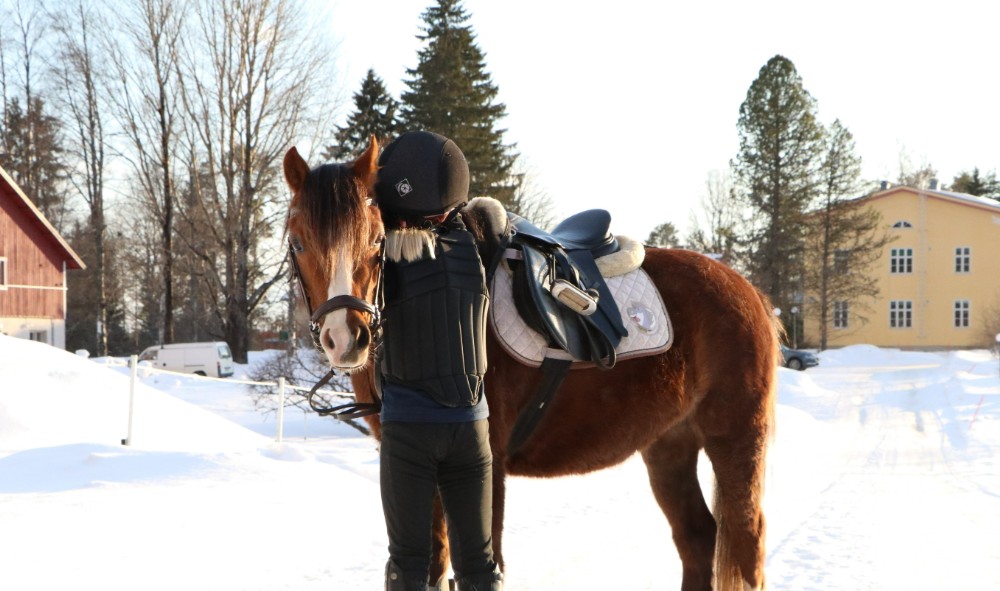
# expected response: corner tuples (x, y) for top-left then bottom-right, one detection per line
(0, 336), (1000, 591)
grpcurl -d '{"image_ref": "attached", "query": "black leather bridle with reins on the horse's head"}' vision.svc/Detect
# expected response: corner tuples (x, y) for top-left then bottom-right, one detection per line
(288, 228), (385, 420)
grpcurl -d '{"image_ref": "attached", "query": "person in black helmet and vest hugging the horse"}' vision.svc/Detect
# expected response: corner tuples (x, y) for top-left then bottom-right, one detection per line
(375, 131), (503, 591)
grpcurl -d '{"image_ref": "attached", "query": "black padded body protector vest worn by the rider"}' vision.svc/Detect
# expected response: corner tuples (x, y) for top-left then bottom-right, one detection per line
(381, 216), (489, 408)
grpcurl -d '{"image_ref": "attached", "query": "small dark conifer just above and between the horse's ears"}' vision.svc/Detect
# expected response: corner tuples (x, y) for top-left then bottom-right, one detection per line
(323, 69), (401, 161)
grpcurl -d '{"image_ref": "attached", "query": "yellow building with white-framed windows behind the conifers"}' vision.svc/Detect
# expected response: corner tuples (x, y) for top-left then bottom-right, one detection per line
(804, 187), (1000, 349)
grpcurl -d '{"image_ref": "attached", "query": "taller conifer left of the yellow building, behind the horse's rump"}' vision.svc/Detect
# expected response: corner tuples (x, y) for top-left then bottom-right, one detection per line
(733, 55), (823, 308)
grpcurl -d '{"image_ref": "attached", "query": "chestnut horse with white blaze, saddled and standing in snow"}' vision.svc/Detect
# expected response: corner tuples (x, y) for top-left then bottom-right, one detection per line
(284, 138), (778, 591)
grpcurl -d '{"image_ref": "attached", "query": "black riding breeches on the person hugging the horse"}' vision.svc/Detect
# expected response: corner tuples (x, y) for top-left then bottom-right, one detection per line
(379, 419), (496, 584)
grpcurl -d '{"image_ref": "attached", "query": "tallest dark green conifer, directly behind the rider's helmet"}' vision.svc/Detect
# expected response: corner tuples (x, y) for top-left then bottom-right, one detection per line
(401, 0), (518, 205)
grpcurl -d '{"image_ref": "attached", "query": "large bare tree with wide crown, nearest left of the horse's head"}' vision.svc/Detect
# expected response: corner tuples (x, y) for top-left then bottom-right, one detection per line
(182, 0), (332, 363)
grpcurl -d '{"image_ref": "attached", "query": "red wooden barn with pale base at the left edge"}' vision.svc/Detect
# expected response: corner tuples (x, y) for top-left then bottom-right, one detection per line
(0, 168), (86, 349)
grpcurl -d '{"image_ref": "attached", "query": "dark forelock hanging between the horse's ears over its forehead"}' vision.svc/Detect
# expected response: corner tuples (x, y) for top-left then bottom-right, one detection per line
(295, 164), (369, 265)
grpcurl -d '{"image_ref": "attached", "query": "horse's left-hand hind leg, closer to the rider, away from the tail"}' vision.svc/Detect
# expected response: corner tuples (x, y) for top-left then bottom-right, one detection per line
(642, 422), (716, 591)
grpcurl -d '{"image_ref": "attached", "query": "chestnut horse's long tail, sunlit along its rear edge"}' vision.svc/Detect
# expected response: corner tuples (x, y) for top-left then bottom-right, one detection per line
(713, 290), (784, 591)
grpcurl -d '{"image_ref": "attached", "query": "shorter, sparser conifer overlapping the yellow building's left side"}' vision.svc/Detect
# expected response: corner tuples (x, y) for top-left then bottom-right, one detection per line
(798, 120), (890, 349)
